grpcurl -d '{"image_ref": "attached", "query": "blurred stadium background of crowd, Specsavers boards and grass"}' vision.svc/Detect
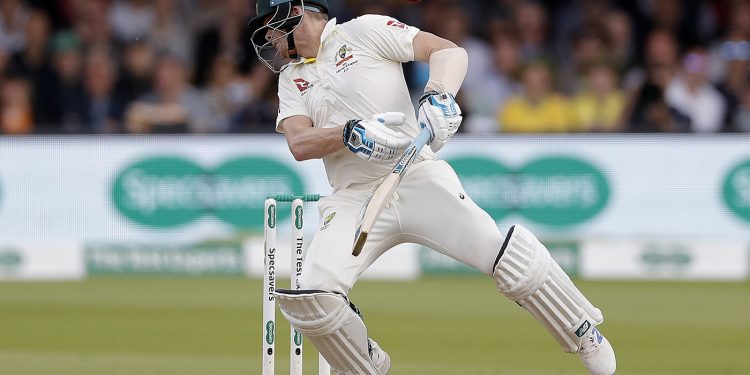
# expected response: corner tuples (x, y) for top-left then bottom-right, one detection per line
(0, 0), (750, 375)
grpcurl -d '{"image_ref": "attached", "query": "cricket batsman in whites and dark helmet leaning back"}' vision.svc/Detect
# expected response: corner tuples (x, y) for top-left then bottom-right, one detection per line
(250, 0), (616, 375)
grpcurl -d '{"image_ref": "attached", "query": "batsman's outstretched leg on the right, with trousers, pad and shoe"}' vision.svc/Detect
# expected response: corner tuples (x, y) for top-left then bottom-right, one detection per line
(396, 162), (615, 375)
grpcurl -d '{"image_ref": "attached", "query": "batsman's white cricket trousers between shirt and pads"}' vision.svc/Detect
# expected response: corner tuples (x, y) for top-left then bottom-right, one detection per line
(300, 160), (505, 295)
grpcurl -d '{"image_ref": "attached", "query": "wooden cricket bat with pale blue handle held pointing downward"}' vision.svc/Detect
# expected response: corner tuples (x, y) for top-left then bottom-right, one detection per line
(352, 127), (431, 256)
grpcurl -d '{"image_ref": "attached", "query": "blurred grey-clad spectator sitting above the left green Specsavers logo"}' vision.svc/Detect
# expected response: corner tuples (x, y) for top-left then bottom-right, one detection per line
(125, 55), (220, 133)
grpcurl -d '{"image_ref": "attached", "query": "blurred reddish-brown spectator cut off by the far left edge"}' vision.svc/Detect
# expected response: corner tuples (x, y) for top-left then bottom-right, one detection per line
(0, 76), (34, 134)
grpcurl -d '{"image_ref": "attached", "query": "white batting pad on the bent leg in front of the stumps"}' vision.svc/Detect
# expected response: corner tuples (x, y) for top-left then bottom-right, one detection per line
(276, 289), (380, 375)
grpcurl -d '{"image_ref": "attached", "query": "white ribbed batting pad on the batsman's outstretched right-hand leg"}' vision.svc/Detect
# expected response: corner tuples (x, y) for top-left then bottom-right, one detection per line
(493, 225), (604, 353)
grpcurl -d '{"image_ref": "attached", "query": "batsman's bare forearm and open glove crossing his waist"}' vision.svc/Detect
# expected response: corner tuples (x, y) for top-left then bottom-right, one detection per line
(281, 112), (409, 164)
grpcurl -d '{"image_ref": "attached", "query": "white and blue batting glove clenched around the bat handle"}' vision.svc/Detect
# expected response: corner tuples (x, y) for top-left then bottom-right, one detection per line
(419, 91), (463, 152)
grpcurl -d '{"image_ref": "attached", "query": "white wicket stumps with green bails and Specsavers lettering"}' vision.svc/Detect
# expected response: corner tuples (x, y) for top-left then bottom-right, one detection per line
(263, 194), (331, 375)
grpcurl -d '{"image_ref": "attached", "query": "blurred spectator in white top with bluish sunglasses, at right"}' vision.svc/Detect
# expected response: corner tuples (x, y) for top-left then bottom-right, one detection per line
(665, 48), (726, 133)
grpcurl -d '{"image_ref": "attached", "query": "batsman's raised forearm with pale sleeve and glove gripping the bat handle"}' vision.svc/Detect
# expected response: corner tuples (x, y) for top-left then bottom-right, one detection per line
(412, 31), (469, 152)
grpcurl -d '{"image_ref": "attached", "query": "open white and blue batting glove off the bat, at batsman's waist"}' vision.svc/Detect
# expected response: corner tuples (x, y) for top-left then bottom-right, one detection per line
(344, 112), (411, 164)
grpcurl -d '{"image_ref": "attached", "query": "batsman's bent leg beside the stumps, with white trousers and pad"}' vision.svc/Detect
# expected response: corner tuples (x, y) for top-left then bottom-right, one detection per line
(276, 190), (399, 375)
